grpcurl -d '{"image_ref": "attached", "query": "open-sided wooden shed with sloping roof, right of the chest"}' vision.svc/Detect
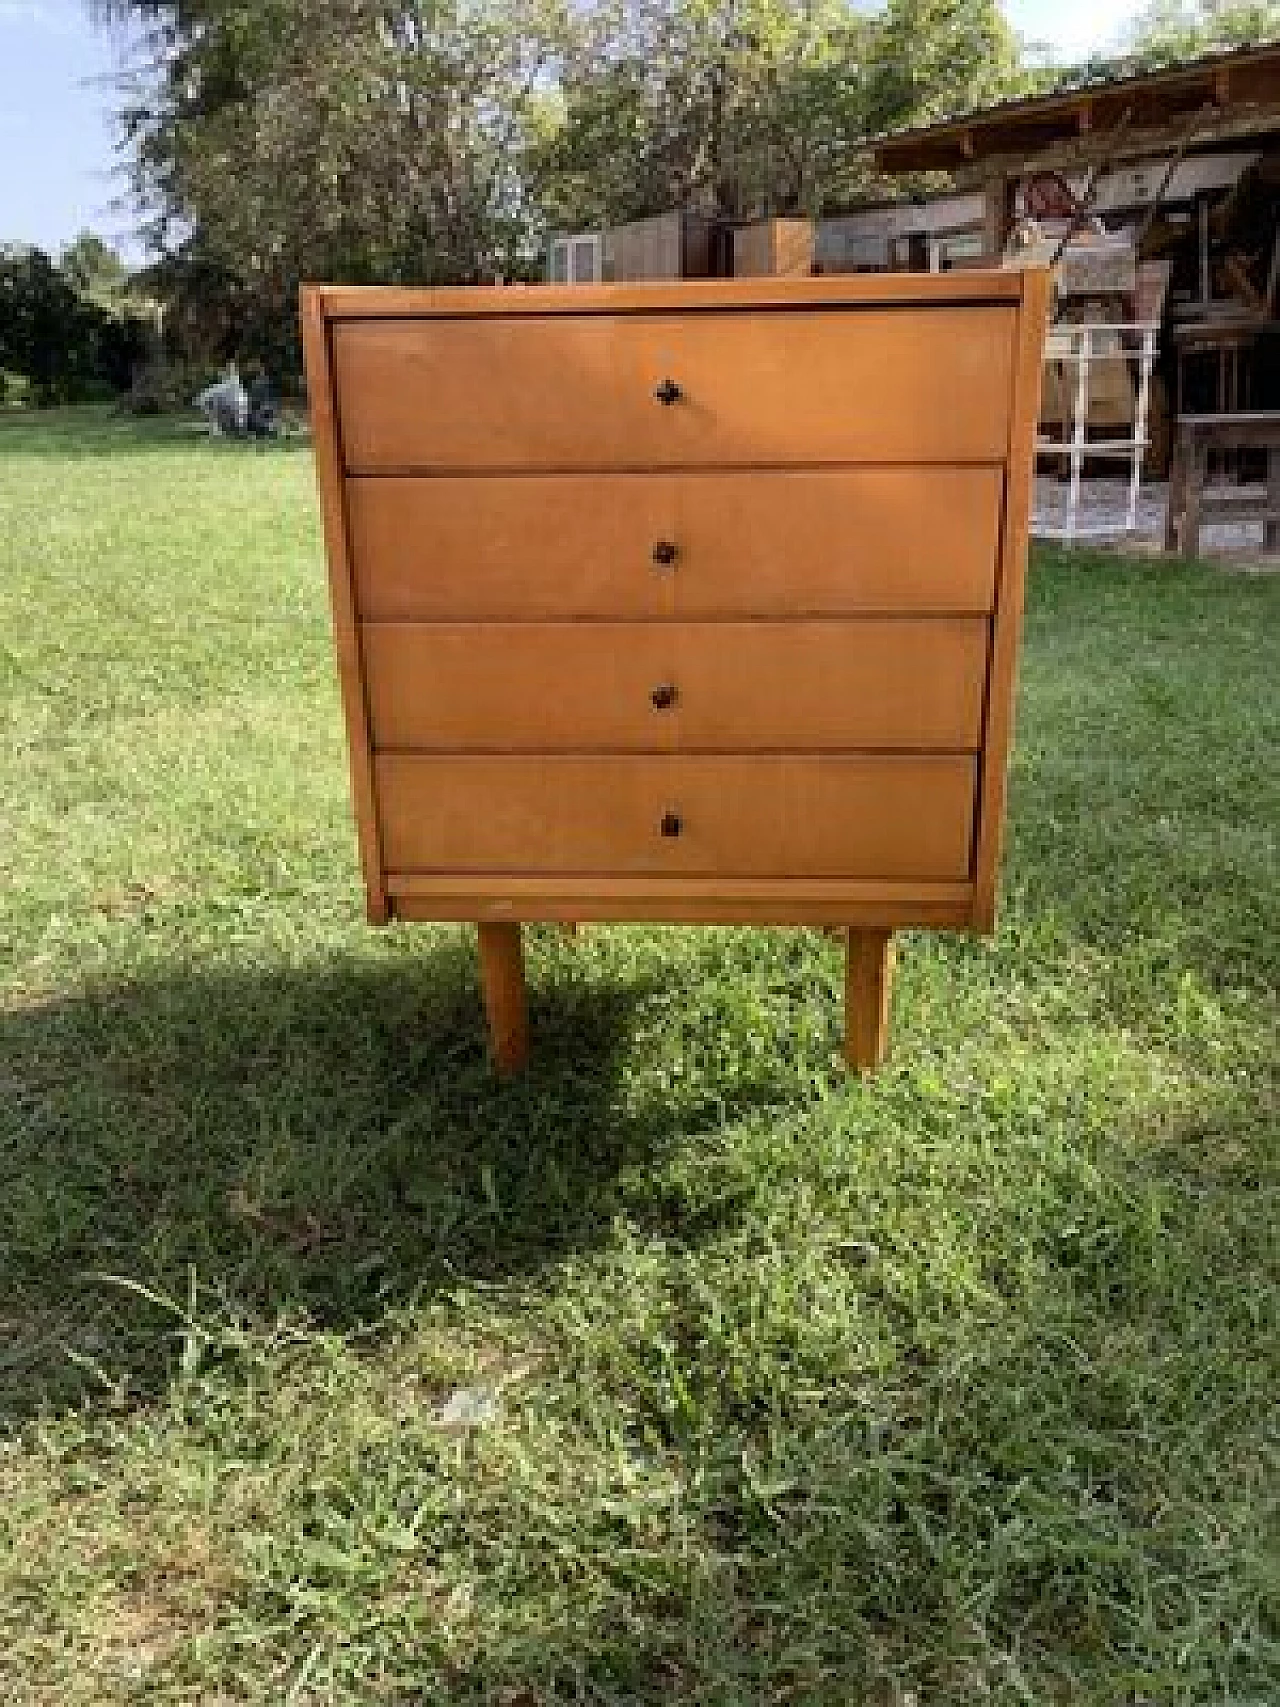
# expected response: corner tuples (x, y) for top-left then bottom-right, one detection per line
(843, 43), (1280, 471)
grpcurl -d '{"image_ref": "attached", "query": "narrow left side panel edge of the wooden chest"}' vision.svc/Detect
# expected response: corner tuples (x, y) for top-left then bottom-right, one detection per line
(300, 287), (389, 925)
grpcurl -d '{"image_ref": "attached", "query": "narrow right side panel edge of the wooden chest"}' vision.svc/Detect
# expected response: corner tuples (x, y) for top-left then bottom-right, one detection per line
(971, 271), (1050, 930)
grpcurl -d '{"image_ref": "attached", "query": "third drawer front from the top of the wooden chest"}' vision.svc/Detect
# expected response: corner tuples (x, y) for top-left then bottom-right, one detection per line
(362, 616), (988, 753)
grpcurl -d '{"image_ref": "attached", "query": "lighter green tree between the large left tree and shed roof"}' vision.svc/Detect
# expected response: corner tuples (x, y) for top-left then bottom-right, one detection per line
(539, 0), (1027, 235)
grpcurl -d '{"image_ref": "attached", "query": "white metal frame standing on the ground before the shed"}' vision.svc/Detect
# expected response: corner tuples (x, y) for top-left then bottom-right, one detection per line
(1031, 321), (1161, 545)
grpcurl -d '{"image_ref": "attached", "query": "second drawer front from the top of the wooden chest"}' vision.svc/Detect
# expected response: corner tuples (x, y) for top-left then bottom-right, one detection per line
(346, 468), (1004, 618)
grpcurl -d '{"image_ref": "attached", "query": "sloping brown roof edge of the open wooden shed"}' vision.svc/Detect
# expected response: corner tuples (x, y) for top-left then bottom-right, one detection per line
(870, 41), (1280, 172)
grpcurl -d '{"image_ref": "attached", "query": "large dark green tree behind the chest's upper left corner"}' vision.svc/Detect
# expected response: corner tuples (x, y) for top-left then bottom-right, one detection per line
(91, 0), (565, 360)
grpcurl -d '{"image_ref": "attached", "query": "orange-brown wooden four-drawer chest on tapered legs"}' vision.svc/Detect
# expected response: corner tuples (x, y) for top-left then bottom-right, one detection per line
(302, 273), (1046, 1067)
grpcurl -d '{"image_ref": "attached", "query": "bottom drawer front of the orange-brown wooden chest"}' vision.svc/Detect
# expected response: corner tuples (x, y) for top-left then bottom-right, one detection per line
(374, 753), (976, 881)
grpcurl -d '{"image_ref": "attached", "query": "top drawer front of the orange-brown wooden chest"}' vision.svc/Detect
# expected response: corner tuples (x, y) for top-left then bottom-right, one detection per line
(333, 307), (1017, 473)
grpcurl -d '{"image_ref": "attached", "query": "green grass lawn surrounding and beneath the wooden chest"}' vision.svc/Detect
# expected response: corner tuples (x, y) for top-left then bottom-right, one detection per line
(0, 402), (1280, 1707)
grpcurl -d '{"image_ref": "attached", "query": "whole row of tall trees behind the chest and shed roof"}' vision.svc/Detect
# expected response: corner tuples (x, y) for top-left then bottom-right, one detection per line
(67, 0), (1280, 369)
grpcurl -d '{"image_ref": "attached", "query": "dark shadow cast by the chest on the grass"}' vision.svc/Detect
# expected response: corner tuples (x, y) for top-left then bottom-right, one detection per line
(0, 937), (761, 1419)
